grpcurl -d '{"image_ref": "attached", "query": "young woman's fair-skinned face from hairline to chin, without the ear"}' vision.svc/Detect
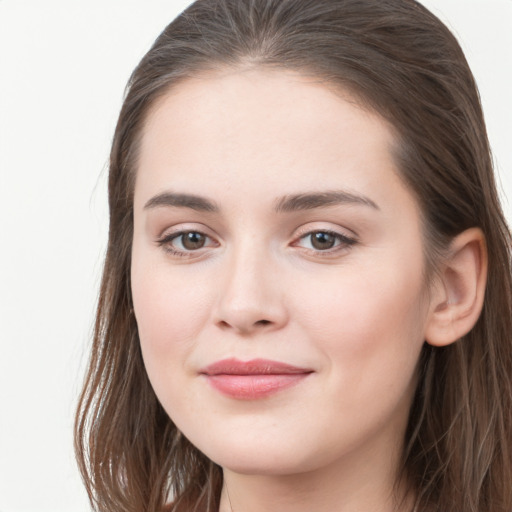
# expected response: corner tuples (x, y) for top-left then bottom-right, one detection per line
(132, 70), (429, 474)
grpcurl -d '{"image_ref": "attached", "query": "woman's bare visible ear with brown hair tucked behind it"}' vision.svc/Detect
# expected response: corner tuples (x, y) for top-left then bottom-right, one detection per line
(425, 228), (487, 347)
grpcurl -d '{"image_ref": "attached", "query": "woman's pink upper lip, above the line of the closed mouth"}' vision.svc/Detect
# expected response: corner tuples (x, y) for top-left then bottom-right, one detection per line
(200, 358), (313, 375)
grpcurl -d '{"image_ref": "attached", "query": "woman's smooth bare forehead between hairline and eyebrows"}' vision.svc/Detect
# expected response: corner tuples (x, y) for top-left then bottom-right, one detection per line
(135, 69), (408, 212)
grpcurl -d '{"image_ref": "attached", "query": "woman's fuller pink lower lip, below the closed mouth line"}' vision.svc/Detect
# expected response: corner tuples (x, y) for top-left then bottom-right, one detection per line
(206, 373), (310, 400)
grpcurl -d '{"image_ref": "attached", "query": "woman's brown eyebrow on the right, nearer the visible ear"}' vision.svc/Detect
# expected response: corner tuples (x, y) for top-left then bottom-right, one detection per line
(275, 190), (380, 212)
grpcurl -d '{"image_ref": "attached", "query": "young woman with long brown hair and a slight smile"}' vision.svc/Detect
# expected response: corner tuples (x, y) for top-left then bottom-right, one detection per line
(76, 0), (512, 512)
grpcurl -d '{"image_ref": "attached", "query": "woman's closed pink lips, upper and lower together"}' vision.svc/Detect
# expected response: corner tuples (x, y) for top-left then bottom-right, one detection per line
(200, 358), (313, 400)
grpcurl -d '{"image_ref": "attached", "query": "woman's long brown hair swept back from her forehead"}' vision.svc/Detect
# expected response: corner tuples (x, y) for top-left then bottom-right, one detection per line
(75, 0), (512, 512)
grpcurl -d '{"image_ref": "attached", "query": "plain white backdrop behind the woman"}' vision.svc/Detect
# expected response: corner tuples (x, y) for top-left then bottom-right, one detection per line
(0, 0), (512, 512)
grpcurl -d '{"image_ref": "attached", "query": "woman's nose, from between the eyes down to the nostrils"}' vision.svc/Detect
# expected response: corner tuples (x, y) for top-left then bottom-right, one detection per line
(214, 245), (288, 336)
